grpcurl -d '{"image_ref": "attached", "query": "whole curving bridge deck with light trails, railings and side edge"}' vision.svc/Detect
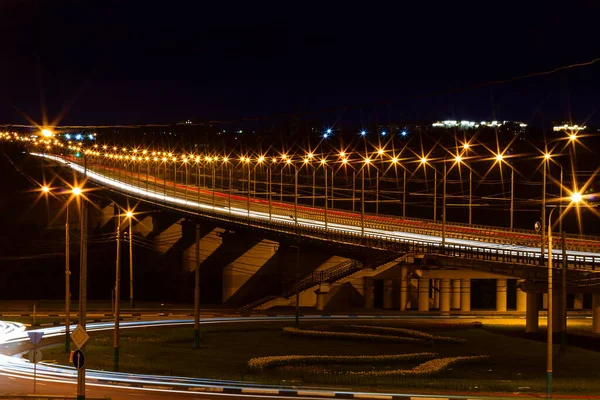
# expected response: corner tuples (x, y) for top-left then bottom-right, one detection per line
(31, 153), (600, 270)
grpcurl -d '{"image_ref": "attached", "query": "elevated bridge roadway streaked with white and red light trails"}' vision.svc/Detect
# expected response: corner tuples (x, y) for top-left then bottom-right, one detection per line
(31, 153), (600, 264)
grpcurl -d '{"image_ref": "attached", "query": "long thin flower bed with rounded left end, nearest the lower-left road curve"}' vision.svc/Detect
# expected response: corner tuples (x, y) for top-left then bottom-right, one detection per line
(248, 353), (438, 371)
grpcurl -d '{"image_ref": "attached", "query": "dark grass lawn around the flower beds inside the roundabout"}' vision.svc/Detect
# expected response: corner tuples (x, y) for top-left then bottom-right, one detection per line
(44, 321), (600, 394)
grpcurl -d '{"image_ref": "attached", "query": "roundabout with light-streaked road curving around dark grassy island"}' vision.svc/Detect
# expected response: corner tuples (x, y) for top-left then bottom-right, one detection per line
(0, 315), (600, 399)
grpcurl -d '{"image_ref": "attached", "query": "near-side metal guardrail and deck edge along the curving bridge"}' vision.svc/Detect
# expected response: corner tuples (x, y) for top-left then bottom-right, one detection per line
(37, 153), (600, 270)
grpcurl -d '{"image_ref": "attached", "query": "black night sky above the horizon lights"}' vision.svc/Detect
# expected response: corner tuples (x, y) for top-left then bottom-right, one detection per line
(0, 0), (600, 124)
